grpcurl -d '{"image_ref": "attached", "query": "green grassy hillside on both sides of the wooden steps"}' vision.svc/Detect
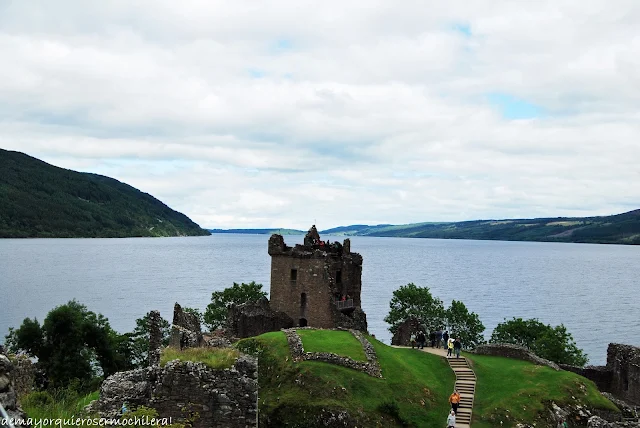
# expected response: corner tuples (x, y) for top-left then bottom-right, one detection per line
(237, 330), (616, 428)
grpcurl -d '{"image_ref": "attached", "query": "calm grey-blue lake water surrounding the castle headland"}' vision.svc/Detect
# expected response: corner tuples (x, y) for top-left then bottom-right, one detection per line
(0, 234), (640, 364)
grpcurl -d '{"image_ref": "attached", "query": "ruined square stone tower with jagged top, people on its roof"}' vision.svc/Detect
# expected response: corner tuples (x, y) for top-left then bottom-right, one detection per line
(269, 225), (367, 331)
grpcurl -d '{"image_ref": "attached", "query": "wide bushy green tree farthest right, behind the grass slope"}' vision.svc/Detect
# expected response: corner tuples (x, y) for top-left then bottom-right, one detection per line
(490, 318), (588, 367)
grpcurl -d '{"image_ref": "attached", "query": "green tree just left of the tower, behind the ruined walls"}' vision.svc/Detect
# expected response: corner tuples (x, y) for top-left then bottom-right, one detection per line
(204, 281), (267, 330)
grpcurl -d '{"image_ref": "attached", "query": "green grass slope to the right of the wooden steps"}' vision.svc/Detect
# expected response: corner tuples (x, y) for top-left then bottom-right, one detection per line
(465, 354), (616, 428)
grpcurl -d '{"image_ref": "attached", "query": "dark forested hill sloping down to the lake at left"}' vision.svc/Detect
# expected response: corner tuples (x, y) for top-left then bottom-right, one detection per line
(0, 149), (209, 238)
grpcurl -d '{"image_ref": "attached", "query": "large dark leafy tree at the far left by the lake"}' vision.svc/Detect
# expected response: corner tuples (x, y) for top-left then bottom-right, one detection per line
(7, 300), (131, 386)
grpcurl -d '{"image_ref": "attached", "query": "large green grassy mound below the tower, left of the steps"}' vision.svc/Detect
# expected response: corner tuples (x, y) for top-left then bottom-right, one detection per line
(237, 330), (454, 427)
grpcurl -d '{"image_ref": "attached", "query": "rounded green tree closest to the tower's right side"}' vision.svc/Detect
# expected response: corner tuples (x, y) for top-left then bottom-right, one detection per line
(384, 283), (445, 333)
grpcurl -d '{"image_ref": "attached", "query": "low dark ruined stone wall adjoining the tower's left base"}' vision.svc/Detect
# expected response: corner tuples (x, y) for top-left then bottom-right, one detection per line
(227, 297), (294, 339)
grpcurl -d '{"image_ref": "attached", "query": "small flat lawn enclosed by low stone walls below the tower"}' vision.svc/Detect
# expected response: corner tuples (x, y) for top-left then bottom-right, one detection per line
(297, 330), (367, 362)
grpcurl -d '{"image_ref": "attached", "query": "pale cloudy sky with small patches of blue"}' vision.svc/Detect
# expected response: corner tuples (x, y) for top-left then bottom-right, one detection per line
(0, 0), (640, 229)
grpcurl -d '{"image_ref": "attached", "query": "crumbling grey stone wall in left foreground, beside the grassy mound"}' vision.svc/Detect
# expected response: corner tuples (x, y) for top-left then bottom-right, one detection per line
(87, 356), (258, 428)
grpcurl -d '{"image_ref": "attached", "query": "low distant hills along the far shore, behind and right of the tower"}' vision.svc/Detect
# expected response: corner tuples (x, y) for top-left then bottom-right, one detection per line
(208, 210), (640, 245)
